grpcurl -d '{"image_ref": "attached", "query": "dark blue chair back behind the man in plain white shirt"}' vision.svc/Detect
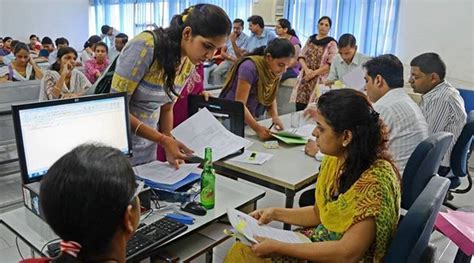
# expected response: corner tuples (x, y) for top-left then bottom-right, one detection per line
(402, 132), (453, 210)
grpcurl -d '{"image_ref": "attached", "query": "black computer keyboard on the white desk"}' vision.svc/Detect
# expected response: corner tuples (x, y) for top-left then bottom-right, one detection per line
(126, 218), (188, 261)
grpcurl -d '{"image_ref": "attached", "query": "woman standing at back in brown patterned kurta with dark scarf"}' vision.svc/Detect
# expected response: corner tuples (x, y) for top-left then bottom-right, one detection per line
(290, 16), (338, 111)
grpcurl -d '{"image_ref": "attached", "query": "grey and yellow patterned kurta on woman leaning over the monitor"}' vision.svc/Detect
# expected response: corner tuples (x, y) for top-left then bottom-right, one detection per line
(111, 32), (194, 165)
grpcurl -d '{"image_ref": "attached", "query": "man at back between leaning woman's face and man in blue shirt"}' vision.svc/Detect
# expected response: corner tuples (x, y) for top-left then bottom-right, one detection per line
(209, 18), (249, 85)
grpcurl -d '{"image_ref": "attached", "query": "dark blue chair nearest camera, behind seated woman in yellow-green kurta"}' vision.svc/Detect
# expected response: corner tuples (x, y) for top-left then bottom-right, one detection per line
(384, 175), (449, 263)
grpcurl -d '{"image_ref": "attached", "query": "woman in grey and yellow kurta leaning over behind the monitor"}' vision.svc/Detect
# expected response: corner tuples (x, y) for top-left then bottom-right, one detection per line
(111, 4), (232, 167)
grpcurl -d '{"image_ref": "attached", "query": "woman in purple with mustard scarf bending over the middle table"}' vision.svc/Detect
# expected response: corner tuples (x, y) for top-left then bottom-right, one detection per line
(219, 38), (295, 140)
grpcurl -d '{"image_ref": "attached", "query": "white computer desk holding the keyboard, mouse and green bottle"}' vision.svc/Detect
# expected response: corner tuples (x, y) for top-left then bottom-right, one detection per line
(0, 175), (265, 258)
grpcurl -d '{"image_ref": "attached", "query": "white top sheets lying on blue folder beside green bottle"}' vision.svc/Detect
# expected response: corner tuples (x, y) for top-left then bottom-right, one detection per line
(133, 161), (200, 185)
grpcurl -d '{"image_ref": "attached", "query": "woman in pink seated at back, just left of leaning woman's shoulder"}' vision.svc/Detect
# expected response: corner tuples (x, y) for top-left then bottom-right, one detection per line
(84, 42), (109, 84)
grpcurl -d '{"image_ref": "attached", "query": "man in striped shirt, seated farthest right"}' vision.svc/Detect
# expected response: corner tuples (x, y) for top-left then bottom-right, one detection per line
(409, 53), (466, 175)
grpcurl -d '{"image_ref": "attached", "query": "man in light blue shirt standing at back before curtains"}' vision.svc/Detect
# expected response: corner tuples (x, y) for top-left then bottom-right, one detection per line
(231, 15), (276, 58)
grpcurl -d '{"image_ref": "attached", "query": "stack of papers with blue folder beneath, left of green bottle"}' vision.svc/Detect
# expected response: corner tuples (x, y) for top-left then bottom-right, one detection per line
(133, 161), (201, 191)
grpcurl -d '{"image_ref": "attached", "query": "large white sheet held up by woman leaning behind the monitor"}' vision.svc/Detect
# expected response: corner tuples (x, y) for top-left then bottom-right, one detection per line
(171, 108), (252, 161)
